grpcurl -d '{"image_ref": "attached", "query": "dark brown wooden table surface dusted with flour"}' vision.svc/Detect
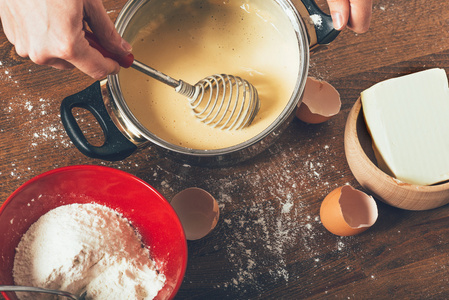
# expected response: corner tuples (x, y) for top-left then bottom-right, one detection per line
(0, 0), (449, 299)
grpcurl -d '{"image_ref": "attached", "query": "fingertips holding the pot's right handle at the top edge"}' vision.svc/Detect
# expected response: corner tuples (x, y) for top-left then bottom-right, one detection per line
(327, 0), (373, 33)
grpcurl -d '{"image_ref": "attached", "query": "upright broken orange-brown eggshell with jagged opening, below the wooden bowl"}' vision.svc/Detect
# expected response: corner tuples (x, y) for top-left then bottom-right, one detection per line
(320, 185), (378, 236)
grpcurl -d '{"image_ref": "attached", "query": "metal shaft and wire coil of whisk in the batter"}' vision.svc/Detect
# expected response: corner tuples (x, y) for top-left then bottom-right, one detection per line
(131, 60), (260, 130)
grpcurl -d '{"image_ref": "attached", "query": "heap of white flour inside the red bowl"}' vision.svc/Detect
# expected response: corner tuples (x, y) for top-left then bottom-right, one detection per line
(13, 204), (165, 299)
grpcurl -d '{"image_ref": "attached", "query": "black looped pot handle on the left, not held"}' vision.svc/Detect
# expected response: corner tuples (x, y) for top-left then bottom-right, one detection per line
(61, 81), (137, 161)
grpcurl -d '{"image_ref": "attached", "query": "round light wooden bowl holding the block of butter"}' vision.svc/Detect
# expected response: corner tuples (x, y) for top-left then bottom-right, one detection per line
(344, 98), (449, 210)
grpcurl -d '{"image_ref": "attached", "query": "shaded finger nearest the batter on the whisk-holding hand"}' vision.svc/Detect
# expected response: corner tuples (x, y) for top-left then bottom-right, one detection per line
(84, 0), (132, 56)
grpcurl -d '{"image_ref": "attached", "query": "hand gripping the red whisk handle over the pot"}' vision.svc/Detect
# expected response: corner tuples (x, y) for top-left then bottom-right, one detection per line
(0, 0), (131, 79)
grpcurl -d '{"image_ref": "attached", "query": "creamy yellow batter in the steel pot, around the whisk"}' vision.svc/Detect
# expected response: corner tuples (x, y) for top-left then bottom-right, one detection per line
(119, 0), (299, 150)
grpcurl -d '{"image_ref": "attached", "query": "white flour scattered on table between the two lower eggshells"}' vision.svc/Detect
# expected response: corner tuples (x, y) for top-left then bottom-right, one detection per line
(138, 137), (351, 299)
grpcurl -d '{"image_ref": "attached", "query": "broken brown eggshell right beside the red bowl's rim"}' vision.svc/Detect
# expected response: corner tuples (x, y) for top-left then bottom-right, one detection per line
(170, 187), (220, 240)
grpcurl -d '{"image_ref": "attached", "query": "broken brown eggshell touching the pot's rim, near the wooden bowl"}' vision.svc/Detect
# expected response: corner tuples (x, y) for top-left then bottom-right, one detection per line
(296, 77), (341, 124)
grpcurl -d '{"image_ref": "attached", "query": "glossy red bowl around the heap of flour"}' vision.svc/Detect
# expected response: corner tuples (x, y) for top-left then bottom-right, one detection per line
(0, 165), (187, 299)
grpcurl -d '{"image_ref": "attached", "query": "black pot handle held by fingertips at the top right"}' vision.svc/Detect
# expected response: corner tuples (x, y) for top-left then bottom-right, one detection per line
(301, 0), (340, 45)
